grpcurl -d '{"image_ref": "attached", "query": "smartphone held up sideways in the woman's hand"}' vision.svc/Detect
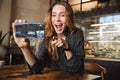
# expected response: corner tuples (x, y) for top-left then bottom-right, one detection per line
(15, 23), (44, 39)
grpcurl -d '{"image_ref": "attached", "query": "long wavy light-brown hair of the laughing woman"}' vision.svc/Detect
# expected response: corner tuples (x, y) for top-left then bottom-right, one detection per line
(35, 1), (76, 60)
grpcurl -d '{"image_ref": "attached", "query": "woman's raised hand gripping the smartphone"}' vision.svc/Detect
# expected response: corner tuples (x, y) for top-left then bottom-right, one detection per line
(12, 20), (30, 48)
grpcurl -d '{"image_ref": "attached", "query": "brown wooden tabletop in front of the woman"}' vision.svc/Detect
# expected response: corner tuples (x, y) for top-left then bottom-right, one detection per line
(0, 64), (98, 80)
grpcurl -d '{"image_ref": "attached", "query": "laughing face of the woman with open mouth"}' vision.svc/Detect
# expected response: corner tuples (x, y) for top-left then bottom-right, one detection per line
(52, 5), (66, 34)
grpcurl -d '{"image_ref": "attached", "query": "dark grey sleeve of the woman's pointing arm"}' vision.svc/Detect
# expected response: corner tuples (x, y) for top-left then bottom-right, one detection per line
(66, 30), (85, 74)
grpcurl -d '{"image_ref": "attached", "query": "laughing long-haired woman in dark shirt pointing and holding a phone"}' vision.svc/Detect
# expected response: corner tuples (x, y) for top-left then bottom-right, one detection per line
(13, 1), (85, 75)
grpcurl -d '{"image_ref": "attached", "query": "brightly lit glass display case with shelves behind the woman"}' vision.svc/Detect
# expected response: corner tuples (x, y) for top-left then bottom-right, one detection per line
(85, 14), (120, 58)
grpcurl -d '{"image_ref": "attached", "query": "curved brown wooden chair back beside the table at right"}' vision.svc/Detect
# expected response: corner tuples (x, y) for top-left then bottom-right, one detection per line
(84, 62), (107, 80)
